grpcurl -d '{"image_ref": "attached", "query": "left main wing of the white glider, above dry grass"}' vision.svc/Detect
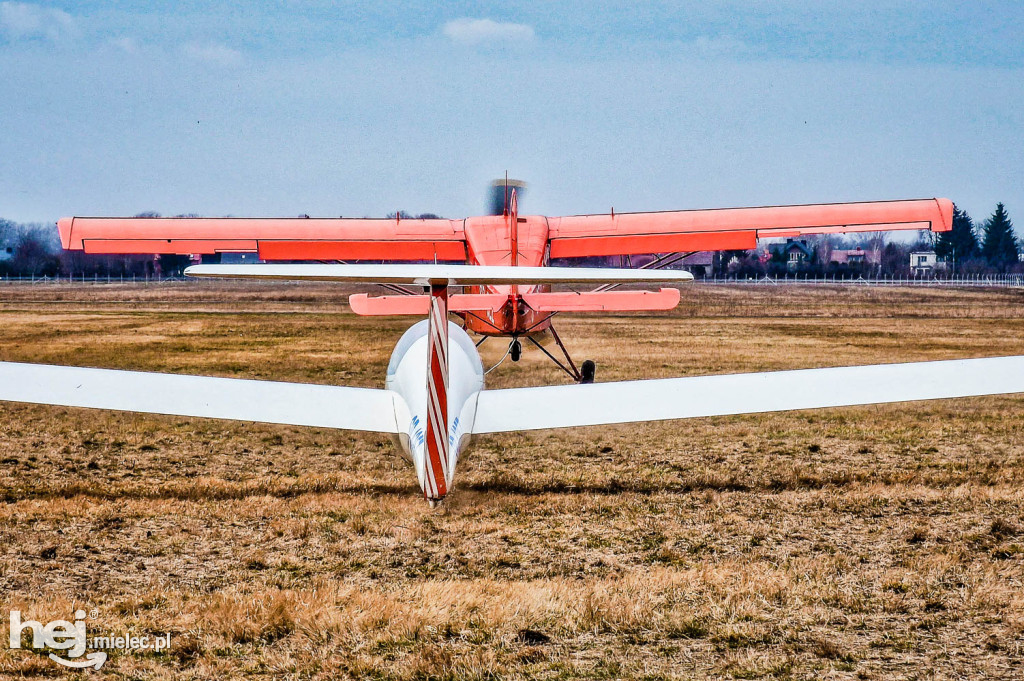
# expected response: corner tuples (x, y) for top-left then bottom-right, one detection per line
(0, 361), (401, 433)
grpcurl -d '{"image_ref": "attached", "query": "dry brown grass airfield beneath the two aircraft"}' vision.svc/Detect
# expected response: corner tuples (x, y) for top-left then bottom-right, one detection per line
(0, 282), (1024, 680)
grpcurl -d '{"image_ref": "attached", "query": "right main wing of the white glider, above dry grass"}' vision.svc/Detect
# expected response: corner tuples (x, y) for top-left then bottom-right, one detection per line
(473, 356), (1024, 433)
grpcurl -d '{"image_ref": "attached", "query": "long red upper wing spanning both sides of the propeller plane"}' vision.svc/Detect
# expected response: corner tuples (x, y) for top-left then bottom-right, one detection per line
(57, 199), (953, 260)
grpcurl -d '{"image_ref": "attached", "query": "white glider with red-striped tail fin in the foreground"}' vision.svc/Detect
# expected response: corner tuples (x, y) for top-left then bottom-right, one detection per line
(0, 265), (1024, 504)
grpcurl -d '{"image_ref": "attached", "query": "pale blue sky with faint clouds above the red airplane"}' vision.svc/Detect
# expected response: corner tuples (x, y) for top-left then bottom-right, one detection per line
(0, 0), (1024, 231)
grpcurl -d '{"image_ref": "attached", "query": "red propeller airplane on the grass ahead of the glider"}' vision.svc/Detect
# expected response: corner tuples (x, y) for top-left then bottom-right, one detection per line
(57, 180), (953, 382)
